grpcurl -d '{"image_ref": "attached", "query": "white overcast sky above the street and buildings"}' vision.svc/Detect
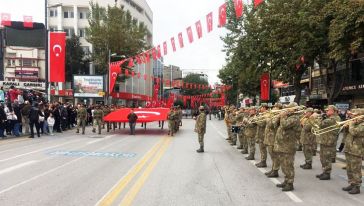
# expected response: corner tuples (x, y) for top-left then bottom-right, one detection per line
(0, 0), (236, 83)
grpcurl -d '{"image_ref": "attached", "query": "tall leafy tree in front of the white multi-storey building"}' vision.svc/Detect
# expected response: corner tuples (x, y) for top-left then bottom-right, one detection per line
(87, 1), (148, 74)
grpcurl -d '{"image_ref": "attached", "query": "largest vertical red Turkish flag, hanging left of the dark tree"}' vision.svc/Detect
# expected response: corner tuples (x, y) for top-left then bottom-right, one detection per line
(49, 32), (66, 82)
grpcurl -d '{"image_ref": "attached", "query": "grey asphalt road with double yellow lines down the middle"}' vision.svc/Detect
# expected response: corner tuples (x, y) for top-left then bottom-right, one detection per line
(0, 119), (364, 206)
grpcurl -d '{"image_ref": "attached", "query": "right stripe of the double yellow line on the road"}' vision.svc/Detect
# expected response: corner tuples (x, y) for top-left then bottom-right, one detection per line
(120, 138), (172, 206)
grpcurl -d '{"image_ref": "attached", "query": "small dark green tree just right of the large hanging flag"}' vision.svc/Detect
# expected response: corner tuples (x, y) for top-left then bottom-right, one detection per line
(66, 35), (89, 82)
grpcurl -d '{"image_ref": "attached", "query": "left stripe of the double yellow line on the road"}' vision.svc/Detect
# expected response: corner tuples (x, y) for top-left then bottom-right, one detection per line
(97, 138), (167, 206)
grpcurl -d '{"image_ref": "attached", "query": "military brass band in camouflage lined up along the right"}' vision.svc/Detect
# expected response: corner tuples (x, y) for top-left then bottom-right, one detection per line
(224, 103), (364, 194)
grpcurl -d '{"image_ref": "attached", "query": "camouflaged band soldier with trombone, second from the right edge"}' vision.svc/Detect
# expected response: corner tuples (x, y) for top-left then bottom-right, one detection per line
(316, 105), (340, 180)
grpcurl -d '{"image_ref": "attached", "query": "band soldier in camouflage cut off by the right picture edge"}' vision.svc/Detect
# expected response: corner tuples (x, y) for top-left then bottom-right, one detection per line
(343, 109), (364, 194)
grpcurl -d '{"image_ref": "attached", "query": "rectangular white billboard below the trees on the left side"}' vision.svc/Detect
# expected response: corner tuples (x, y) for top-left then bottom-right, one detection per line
(73, 76), (105, 97)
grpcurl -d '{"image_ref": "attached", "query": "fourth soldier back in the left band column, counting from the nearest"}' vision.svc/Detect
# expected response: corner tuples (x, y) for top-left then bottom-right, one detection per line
(244, 107), (257, 160)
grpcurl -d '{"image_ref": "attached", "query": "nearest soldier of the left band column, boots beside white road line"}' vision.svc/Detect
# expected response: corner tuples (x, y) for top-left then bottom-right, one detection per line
(274, 103), (300, 192)
